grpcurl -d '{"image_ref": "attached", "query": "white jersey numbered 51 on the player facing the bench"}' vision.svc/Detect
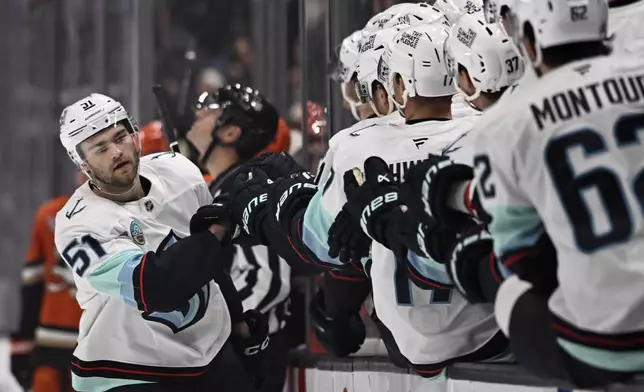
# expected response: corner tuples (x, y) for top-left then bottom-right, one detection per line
(55, 153), (231, 391)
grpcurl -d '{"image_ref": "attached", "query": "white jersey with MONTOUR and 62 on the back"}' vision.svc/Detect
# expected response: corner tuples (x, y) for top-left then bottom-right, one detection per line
(474, 56), (644, 371)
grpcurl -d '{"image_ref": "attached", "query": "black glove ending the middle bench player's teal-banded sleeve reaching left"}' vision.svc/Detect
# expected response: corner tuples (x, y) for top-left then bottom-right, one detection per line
(268, 172), (318, 233)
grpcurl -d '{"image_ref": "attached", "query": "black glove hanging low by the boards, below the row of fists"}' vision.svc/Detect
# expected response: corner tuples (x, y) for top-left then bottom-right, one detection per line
(309, 289), (367, 357)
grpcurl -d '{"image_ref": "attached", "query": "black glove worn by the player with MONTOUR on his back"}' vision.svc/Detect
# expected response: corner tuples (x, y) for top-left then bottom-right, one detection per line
(447, 225), (494, 303)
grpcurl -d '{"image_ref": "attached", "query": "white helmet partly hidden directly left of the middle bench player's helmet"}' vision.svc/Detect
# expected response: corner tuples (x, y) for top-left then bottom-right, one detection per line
(356, 27), (400, 116)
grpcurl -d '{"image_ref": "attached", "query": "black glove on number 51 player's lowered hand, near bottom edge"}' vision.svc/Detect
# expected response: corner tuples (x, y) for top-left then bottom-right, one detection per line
(230, 310), (270, 388)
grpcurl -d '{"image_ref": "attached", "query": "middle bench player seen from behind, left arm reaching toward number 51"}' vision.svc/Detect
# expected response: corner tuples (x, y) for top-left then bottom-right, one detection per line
(228, 19), (506, 378)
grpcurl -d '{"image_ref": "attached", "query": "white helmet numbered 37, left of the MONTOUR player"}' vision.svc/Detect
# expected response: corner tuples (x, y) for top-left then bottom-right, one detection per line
(444, 15), (525, 102)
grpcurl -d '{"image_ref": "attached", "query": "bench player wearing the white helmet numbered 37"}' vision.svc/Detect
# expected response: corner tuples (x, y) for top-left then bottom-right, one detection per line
(392, 15), (524, 303)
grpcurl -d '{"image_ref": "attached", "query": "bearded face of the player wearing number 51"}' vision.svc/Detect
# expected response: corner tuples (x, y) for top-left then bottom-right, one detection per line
(80, 124), (139, 190)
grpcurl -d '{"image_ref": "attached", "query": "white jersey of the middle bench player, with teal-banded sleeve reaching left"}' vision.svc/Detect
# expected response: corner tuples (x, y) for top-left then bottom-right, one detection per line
(303, 112), (498, 365)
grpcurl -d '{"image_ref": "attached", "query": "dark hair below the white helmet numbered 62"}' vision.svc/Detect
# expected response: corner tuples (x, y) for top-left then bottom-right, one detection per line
(523, 22), (611, 67)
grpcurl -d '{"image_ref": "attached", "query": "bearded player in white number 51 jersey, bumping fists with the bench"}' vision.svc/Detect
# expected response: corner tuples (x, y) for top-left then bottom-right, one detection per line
(55, 94), (268, 391)
